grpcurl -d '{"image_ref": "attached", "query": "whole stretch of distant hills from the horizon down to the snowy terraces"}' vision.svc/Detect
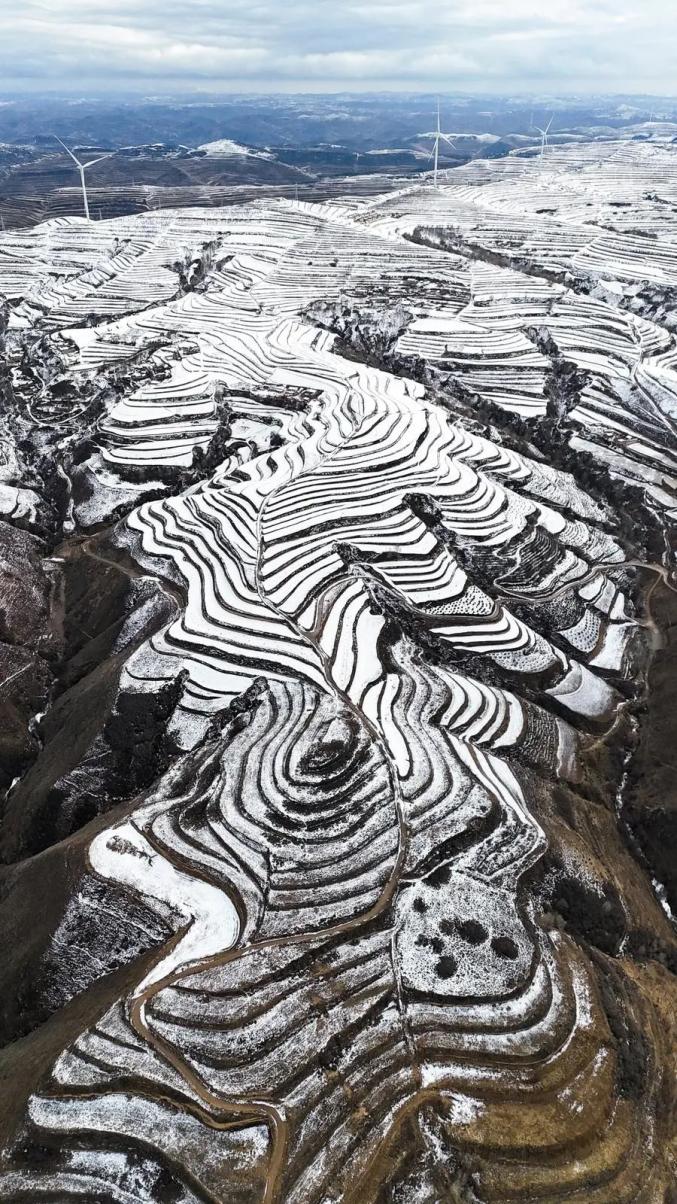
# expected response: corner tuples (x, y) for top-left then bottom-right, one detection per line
(0, 94), (677, 229)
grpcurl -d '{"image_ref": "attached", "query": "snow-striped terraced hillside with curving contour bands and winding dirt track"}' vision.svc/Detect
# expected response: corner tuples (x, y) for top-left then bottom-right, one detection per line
(0, 144), (677, 1204)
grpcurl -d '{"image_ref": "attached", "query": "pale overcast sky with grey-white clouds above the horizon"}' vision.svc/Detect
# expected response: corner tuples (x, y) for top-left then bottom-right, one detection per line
(0, 0), (677, 94)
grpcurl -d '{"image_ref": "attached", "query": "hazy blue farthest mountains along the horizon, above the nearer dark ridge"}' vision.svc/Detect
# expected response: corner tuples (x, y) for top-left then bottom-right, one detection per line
(0, 93), (677, 151)
